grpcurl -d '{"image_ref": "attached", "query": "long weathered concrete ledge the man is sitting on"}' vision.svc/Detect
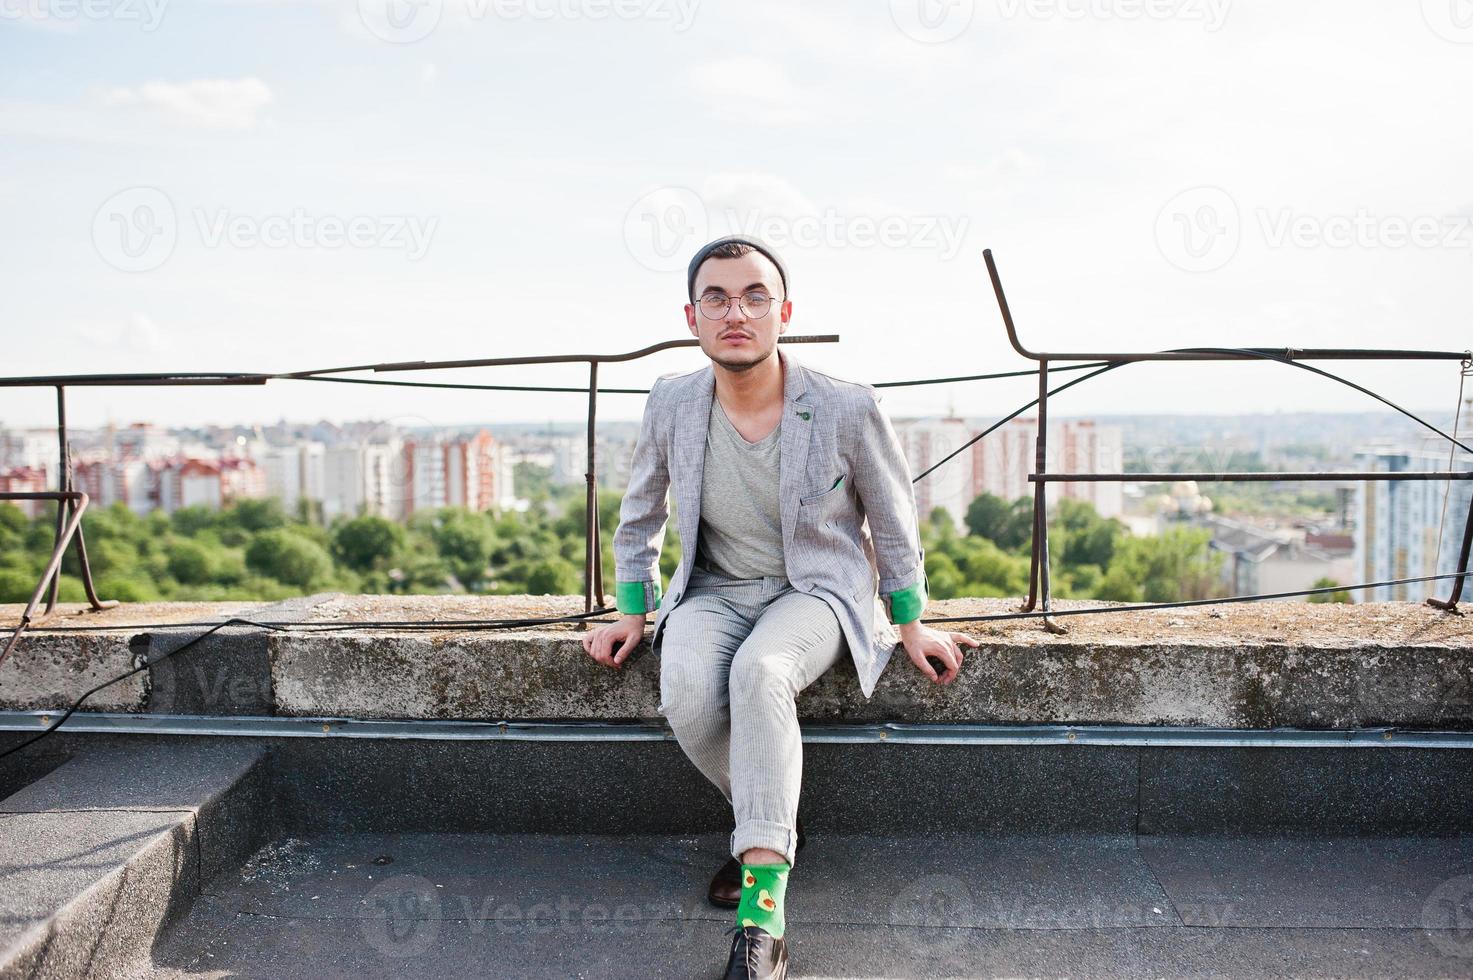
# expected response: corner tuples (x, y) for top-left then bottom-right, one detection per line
(0, 595), (1473, 731)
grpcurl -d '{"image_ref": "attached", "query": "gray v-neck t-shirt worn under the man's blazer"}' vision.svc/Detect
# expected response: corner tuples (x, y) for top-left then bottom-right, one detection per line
(697, 395), (787, 579)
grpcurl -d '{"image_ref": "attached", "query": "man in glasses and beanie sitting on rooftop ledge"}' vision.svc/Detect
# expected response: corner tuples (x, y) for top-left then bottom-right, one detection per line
(583, 236), (980, 977)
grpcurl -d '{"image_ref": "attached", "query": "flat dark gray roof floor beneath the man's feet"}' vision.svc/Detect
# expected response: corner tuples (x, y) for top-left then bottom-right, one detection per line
(129, 831), (1473, 979)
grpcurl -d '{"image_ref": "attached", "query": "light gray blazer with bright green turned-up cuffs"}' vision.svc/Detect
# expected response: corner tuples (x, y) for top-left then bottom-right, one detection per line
(614, 345), (928, 699)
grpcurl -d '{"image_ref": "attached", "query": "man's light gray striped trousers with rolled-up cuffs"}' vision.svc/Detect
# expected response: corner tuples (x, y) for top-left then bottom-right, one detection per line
(658, 566), (848, 865)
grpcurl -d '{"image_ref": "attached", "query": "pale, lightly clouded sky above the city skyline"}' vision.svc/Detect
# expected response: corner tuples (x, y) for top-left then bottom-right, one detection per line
(0, 0), (1473, 426)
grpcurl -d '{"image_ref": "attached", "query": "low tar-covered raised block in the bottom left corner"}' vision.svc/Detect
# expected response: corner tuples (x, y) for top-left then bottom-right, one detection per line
(0, 735), (267, 980)
